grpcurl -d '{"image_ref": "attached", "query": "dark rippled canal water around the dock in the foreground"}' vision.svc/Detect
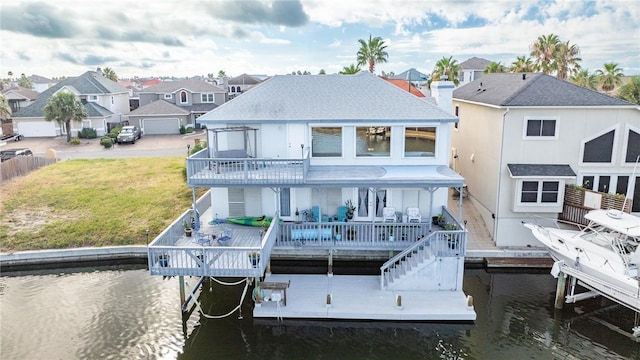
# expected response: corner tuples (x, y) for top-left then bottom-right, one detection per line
(0, 268), (640, 360)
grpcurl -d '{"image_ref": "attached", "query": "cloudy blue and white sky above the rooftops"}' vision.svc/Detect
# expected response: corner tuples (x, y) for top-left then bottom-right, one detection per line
(0, 0), (640, 78)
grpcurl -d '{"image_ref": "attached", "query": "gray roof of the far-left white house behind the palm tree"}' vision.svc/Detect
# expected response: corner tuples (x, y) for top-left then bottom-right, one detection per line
(12, 71), (129, 118)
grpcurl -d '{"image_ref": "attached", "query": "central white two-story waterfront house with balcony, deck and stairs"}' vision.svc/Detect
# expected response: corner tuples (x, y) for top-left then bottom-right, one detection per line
(149, 72), (475, 319)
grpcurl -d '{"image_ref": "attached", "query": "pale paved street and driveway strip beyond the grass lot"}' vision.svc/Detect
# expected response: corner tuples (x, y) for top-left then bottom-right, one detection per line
(0, 131), (206, 160)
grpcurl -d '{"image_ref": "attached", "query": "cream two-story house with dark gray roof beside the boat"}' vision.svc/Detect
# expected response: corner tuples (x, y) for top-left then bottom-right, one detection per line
(451, 73), (640, 246)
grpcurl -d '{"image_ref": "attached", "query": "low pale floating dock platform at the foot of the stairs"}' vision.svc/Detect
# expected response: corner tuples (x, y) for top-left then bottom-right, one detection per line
(253, 274), (476, 321)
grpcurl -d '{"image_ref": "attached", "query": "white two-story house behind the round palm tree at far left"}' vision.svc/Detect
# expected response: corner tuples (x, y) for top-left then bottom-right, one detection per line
(12, 71), (129, 137)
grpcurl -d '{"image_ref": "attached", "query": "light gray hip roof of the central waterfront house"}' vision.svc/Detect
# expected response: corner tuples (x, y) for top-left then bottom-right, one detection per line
(199, 71), (457, 122)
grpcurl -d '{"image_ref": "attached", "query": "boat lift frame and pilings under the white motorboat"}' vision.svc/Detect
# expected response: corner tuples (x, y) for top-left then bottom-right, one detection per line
(551, 260), (640, 338)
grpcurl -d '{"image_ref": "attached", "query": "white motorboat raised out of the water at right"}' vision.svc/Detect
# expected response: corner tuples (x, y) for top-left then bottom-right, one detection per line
(524, 210), (640, 316)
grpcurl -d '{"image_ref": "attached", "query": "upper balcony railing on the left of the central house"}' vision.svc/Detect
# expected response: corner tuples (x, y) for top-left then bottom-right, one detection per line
(187, 155), (309, 186)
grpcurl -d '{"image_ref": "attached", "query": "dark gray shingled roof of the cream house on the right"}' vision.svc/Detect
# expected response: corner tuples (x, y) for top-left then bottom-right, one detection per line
(453, 73), (634, 107)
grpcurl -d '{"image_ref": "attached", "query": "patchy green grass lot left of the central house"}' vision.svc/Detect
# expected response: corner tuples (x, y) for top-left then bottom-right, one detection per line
(0, 157), (192, 252)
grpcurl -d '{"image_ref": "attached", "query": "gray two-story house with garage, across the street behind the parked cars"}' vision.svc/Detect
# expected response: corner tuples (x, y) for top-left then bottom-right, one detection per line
(135, 79), (227, 134)
